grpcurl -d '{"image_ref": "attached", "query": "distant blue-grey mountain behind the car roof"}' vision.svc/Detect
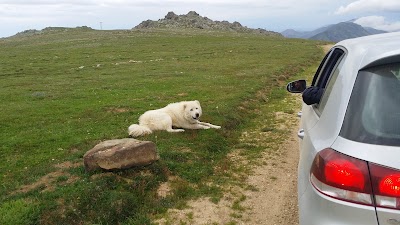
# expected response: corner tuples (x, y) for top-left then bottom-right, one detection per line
(281, 22), (386, 42)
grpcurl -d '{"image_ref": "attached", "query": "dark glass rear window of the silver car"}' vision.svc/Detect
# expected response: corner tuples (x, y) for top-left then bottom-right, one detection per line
(340, 62), (400, 146)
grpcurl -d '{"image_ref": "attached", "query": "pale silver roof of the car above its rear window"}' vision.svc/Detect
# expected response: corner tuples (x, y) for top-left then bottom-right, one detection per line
(334, 32), (400, 69)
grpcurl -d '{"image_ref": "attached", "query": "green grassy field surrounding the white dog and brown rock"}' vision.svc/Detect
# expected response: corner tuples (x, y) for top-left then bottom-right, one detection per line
(0, 29), (322, 224)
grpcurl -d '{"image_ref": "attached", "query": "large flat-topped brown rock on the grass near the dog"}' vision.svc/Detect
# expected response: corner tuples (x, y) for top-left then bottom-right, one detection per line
(83, 138), (159, 171)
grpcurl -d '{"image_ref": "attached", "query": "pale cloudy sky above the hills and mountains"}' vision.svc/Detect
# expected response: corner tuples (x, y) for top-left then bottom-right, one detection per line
(0, 0), (400, 37)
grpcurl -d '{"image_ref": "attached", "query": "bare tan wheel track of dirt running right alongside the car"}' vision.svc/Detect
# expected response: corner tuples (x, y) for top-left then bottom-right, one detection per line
(239, 127), (298, 225)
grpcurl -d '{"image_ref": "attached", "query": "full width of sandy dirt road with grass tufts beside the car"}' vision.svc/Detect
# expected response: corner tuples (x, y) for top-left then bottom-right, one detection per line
(154, 96), (301, 225)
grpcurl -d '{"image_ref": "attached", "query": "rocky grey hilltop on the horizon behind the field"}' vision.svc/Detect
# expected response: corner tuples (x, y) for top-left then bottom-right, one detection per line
(133, 11), (282, 36)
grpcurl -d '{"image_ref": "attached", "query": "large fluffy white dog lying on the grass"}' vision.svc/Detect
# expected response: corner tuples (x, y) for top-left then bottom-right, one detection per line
(128, 100), (221, 137)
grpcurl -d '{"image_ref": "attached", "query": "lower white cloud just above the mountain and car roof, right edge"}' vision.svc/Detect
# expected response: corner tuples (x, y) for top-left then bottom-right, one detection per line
(354, 16), (400, 32)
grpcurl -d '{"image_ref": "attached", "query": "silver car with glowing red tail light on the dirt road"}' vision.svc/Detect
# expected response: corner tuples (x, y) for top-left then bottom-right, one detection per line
(287, 32), (400, 225)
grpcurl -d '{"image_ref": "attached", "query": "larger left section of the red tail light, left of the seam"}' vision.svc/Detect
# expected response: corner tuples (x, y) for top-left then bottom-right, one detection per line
(311, 148), (372, 205)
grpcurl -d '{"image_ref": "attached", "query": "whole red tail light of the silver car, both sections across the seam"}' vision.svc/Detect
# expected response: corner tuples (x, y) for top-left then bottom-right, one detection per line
(311, 148), (400, 209)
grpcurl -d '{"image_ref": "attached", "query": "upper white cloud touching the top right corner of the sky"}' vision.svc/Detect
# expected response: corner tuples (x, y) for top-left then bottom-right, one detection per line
(335, 0), (400, 15)
